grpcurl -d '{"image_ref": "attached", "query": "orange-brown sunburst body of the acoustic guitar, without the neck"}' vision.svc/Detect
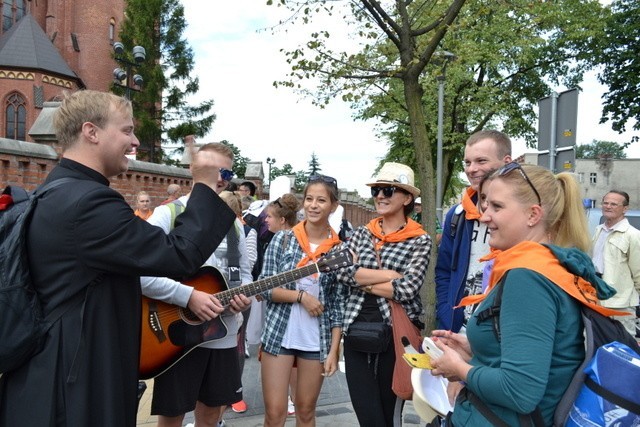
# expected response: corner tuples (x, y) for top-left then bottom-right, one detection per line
(139, 266), (227, 379)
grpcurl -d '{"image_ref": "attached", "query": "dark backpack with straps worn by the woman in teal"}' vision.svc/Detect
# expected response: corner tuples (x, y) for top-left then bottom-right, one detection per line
(467, 273), (640, 426)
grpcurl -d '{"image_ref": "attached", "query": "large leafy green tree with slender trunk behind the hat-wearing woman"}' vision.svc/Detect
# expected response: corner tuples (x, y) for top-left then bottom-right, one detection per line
(276, 0), (601, 332)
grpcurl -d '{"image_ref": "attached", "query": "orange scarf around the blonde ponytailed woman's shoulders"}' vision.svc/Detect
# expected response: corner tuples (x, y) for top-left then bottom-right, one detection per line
(458, 241), (624, 316)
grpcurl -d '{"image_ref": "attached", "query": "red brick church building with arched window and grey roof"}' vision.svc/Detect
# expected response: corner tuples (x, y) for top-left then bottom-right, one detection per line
(0, 0), (125, 141)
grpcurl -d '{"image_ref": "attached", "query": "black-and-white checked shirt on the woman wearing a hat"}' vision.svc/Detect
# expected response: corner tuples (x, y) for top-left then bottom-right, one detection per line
(337, 226), (431, 333)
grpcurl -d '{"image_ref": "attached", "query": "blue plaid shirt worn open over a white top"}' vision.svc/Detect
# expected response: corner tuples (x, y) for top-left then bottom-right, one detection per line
(260, 230), (342, 361)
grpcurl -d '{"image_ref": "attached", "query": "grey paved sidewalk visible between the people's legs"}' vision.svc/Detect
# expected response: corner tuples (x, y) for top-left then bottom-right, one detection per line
(137, 346), (425, 427)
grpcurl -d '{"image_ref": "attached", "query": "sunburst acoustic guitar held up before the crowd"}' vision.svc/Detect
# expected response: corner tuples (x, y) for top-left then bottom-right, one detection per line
(140, 250), (352, 379)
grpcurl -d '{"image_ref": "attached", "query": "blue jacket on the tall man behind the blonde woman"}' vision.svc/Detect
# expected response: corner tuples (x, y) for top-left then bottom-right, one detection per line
(436, 196), (477, 332)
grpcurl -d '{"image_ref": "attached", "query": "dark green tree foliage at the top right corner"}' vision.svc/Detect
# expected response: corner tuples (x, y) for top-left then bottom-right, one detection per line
(598, 0), (640, 142)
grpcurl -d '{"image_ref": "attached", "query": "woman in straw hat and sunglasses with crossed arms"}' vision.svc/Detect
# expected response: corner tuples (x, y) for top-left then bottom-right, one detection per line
(338, 163), (431, 427)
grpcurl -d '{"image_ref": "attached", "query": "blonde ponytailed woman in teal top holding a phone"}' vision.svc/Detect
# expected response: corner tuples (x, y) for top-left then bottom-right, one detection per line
(432, 163), (628, 425)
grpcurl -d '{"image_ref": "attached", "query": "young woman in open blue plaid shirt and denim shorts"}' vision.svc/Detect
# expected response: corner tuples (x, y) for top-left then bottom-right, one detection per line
(260, 175), (342, 427)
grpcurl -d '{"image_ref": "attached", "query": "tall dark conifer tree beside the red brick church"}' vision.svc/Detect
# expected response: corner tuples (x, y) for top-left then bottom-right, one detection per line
(119, 0), (215, 162)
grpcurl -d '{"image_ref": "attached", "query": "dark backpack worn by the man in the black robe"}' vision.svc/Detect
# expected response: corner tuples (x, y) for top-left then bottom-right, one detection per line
(0, 178), (85, 372)
